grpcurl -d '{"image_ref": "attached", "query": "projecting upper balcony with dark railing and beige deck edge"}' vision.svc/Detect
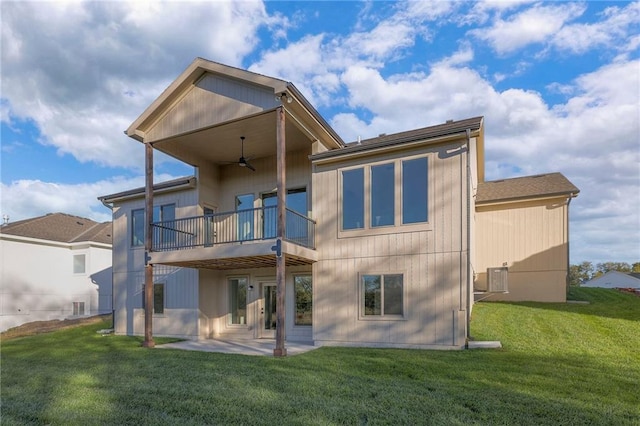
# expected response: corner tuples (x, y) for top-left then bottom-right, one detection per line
(151, 206), (317, 269)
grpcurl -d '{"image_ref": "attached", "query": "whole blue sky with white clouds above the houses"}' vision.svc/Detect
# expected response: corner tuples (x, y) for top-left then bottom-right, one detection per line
(0, 1), (640, 263)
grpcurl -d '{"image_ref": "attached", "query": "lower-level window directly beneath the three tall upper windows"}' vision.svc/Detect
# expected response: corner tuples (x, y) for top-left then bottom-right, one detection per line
(361, 274), (404, 317)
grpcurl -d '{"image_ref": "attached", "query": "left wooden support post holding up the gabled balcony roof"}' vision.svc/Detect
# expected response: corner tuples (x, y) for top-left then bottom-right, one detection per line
(142, 143), (156, 348)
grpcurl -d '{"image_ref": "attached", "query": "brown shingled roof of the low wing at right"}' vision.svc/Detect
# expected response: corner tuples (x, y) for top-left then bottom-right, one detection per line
(476, 173), (580, 204)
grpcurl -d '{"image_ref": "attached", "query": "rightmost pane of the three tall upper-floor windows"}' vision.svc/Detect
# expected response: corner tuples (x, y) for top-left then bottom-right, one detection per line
(402, 157), (428, 223)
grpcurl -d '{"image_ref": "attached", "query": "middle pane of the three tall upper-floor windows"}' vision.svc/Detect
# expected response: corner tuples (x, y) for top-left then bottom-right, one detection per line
(371, 163), (395, 226)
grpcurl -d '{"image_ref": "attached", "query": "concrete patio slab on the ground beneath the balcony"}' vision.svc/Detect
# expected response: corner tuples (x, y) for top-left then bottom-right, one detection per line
(156, 339), (318, 356)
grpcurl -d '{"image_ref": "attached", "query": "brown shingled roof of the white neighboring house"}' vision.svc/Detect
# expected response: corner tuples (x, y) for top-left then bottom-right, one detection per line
(0, 213), (112, 244)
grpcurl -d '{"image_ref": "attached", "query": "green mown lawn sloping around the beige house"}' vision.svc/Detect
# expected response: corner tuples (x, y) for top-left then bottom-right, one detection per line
(0, 289), (640, 425)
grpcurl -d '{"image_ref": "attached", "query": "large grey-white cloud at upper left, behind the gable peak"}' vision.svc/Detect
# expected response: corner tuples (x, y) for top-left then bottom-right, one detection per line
(2, 2), (277, 167)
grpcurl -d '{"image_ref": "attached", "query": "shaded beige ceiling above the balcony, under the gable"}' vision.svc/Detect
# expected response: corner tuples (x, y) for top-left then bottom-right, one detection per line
(153, 110), (313, 166)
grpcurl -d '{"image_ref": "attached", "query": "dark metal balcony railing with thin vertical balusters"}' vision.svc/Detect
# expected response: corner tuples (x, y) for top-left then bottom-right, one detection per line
(151, 206), (316, 251)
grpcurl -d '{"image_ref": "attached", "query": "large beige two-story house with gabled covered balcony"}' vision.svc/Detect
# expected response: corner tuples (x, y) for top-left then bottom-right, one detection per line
(100, 58), (577, 354)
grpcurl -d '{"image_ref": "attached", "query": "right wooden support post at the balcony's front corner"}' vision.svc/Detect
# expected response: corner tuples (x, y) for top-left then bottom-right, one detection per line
(273, 106), (287, 357)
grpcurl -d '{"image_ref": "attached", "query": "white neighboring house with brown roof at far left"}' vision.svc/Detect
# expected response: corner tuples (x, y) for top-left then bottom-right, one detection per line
(0, 213), (112, 331)
